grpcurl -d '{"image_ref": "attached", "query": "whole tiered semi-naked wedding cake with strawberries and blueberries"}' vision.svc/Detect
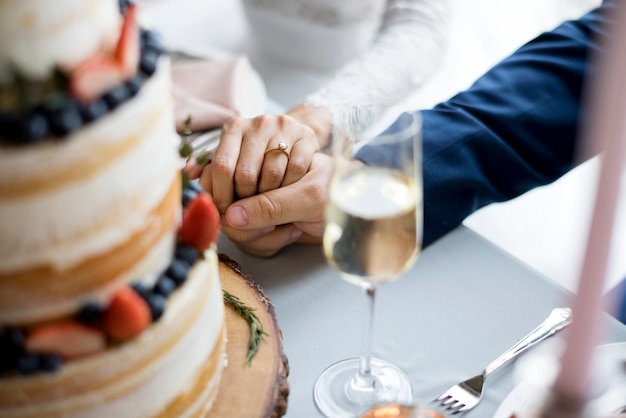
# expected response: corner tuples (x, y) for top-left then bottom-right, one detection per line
(0, 0), (226, 418)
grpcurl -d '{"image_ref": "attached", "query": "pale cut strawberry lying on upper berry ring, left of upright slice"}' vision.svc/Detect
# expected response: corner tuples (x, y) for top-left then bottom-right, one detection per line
(70, 55), (123, 102)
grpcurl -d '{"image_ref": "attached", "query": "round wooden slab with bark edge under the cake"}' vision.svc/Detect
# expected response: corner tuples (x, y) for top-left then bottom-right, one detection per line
(208, 254), (289, 418)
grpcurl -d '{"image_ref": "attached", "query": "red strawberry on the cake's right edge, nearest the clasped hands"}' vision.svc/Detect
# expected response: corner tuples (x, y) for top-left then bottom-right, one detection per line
(180, 192), (220, 252)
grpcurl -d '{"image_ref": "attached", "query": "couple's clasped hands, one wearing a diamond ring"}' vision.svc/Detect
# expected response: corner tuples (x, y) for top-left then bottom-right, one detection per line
(185, 109), (332, 257)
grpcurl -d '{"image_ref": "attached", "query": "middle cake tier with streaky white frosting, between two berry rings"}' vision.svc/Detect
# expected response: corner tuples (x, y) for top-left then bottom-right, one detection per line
(0, 59), (181, 325)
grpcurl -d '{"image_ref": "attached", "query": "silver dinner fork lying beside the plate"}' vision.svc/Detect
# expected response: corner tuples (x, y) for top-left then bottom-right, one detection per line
(435, 308), (572, 415)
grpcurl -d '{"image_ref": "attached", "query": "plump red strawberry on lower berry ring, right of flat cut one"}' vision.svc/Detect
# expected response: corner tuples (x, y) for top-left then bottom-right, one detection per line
(102, 287), (152, 341)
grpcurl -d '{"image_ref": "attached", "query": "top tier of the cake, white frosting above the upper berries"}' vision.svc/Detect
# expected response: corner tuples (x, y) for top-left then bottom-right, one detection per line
(0, 0), (121, 84)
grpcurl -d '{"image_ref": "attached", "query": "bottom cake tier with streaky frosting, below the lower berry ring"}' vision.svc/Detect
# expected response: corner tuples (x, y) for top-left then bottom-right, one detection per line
(0, 251), (225, 418)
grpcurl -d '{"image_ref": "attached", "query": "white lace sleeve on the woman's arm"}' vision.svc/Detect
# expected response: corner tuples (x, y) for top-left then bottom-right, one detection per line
(303, 0), (450, 139)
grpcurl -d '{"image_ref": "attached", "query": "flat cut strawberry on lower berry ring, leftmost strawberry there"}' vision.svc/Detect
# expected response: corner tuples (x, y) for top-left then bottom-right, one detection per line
(25, 320), (106, 359)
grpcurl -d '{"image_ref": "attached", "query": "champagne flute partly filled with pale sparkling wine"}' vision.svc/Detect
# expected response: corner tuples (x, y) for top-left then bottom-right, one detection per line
(314, 113), (422, 418)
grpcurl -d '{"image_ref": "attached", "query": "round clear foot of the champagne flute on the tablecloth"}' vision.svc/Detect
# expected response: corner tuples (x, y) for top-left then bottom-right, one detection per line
(313, 358), (413, 418)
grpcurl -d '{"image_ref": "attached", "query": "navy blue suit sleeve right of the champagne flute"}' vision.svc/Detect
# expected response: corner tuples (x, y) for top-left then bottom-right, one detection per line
(357, 2), (613, 245)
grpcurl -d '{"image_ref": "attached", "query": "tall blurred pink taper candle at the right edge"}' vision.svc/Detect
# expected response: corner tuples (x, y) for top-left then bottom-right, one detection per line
(552, 2), (626, 407)
